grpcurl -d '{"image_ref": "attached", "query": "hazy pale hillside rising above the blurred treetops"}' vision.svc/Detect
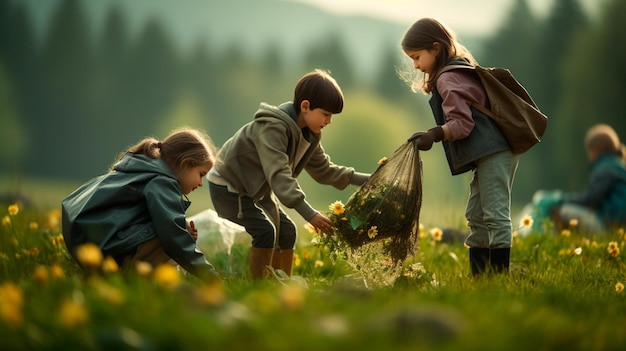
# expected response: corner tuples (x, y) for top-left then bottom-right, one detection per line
(15, 0), (476, 75)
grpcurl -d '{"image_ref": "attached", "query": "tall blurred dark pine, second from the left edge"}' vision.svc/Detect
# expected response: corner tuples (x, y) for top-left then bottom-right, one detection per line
(37, 0), (97, 177)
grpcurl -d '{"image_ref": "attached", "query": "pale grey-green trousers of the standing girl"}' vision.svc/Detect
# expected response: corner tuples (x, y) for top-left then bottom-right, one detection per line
(465, 150), (519, 249)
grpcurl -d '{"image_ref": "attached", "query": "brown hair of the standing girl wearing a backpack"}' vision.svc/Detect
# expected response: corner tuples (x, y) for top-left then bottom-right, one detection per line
(399, 18), (478, 94)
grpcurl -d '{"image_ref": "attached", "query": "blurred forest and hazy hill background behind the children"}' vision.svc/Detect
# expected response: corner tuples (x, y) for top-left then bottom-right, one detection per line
(0, 0), (626, 221)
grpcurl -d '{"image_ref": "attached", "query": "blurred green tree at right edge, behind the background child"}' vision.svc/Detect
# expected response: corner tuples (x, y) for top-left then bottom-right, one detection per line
(554, 0), (626, 189)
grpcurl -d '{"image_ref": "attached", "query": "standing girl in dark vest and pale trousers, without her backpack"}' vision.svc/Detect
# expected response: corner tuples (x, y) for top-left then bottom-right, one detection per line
(401, 18), (518, 276)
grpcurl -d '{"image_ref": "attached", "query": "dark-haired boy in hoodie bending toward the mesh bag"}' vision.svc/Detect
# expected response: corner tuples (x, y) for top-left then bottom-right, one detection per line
(208, 70), (369, 280)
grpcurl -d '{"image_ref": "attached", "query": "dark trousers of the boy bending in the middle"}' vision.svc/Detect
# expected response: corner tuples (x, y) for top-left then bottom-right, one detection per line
(209, 182), (296, 249)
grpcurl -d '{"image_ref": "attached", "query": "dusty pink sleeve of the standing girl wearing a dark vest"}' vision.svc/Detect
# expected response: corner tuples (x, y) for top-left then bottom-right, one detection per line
(437, 70), (487, 140)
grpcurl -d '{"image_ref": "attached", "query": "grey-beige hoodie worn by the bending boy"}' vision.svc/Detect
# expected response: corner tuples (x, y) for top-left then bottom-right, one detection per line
(208, 103), (369, 221)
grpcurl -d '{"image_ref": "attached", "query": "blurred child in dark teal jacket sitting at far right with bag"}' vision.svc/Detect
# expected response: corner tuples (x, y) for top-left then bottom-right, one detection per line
(533, 124), (626, 234)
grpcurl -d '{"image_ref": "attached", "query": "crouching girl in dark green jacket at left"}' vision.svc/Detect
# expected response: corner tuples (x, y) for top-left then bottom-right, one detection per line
(62, 128), (217, 282)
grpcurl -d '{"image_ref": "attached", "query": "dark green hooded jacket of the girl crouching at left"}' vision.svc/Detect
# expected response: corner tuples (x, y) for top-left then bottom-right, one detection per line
(62, 153), (215, 280)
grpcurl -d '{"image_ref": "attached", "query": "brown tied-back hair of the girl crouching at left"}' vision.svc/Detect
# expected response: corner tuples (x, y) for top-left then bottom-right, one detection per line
(116, 127), (217, 171)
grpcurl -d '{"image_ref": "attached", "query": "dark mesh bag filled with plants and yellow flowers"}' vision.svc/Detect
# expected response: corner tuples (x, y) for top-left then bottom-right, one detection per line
(325, 142), (422, 286)
